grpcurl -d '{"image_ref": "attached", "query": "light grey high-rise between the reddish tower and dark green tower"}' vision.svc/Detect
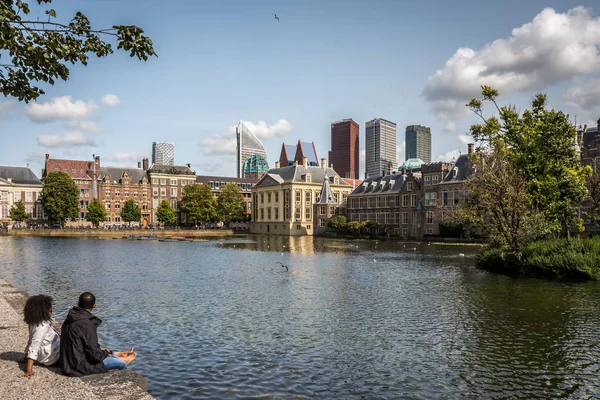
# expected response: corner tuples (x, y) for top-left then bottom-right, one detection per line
(365, 118), (398, 177)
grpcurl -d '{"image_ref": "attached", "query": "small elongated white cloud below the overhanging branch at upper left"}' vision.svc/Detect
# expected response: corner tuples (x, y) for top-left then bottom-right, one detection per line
(25, 96), (98, 122)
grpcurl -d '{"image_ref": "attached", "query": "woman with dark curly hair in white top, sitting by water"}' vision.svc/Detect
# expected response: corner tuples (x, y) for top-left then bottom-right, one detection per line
(23, 294), (60, 377)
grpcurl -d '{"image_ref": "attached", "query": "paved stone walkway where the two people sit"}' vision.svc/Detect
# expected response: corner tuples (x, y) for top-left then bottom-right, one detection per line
(0, 279), (154, 400)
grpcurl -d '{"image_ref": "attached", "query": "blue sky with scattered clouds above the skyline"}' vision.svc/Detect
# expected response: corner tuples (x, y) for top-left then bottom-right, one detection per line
(0, 0), (600, 176)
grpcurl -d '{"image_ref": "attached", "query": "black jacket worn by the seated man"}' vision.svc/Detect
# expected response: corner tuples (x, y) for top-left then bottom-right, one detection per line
(60, 307), (108, 376)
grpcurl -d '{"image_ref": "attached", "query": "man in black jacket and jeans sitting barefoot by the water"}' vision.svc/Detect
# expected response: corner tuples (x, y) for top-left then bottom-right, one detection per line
(60, 292), (135, 376)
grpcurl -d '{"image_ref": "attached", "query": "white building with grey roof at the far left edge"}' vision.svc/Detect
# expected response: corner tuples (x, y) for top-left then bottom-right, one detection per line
(0, 165), (45, 225)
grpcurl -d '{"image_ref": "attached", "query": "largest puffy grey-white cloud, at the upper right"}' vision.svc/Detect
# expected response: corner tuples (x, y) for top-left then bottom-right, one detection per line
(423, 7), (600, 119)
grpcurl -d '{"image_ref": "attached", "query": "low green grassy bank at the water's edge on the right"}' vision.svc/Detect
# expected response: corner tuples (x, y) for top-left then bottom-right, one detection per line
(476, 236), (600, 280)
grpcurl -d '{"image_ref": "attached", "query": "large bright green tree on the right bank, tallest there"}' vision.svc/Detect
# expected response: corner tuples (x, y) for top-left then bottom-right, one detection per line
(468, 86), (591, 236)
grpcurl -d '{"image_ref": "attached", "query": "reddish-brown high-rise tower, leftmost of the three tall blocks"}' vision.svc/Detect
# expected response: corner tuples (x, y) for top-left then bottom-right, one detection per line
(329, 119), (360, 179)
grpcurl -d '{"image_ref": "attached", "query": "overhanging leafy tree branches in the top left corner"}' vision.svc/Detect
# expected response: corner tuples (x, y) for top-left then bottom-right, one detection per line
(0, 0), (156, 102)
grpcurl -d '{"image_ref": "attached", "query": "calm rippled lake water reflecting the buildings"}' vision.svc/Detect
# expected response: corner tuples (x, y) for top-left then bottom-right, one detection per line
(0, 236), (600, 399)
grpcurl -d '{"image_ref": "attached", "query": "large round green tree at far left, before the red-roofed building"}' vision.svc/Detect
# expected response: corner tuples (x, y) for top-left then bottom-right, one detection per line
(41, 171), (79, 226)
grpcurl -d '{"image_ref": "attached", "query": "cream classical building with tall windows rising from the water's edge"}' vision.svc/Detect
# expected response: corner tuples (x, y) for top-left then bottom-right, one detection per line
(250, 158), (352, 236)
